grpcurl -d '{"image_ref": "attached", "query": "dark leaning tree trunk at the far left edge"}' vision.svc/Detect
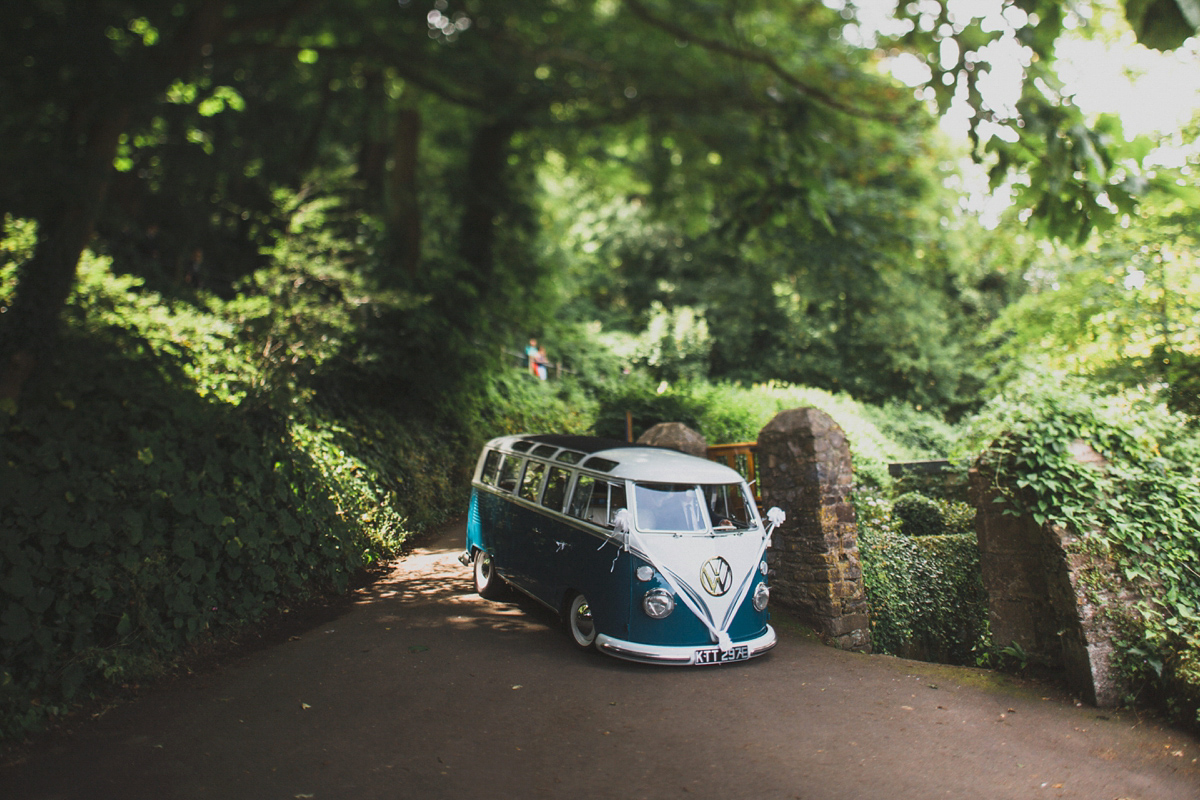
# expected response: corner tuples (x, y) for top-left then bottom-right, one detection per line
(0, 103), (128, 403)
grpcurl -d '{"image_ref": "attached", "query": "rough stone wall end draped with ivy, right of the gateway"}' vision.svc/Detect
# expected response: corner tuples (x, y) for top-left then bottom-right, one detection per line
(970, 443), (1135, 708)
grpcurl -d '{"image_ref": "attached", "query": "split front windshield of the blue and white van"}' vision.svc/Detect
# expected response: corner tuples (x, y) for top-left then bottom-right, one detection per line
(634, 483), (755, 534)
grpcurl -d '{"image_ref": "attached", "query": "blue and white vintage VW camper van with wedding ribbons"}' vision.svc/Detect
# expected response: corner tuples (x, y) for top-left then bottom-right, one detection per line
(460, 435), (782, 664)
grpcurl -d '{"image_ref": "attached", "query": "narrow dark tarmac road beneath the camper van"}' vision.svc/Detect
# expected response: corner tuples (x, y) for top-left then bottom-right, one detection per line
(0, 524), (1200, 800)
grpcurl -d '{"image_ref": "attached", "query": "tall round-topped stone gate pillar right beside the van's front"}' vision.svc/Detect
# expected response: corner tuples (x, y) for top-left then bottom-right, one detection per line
(757, 408), (871, 652)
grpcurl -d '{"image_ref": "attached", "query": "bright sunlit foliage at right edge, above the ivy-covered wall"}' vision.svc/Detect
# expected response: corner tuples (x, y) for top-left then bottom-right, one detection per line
(989, 182), (1200, 415)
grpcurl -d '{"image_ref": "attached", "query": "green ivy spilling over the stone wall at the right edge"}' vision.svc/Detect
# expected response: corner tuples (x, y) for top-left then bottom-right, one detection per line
(964, 381), (1200, 724)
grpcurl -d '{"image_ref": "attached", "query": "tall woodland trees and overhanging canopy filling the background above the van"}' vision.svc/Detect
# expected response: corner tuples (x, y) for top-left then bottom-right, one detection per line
(7, 0), (1188, 416)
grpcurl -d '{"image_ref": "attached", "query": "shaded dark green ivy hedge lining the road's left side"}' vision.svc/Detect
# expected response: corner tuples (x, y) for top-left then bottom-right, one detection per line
(0, 331), (383, 735)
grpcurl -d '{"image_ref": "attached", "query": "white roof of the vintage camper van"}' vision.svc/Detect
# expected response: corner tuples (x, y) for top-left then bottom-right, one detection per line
(487, 434), (743, 483)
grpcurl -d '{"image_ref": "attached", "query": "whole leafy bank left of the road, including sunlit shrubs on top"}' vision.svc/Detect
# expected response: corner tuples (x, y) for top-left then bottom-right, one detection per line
(0, 223), (586, 735)
